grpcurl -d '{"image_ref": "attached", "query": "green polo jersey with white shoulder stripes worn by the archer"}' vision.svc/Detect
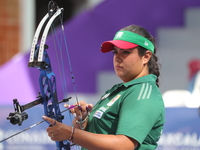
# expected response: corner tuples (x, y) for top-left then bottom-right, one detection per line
(82, 74), (165, 150)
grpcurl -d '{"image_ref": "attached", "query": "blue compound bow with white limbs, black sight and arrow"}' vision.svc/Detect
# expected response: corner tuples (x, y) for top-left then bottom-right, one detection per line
(0, 1), (78, 150)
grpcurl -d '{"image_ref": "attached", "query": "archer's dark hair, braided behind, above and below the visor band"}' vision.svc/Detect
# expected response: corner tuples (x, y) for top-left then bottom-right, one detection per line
(121, 25), (160, 87)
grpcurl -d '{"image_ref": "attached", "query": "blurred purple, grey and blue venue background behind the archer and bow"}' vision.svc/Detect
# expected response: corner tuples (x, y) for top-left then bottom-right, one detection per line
(0, 0), (200, 150)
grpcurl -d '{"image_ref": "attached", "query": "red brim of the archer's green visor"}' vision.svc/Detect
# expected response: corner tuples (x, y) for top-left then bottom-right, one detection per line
(101, 40), (138, 53)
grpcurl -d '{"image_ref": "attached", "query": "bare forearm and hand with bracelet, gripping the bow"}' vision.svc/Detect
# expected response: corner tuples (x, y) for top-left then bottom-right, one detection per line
(43, 116), (138, 150)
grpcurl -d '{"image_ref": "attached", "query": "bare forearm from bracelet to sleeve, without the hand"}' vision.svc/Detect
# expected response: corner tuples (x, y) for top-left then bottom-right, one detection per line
(73, 129), (137, 150)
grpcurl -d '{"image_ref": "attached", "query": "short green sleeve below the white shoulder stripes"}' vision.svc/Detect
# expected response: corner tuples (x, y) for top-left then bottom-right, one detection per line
(116, 86), (162, 144)
